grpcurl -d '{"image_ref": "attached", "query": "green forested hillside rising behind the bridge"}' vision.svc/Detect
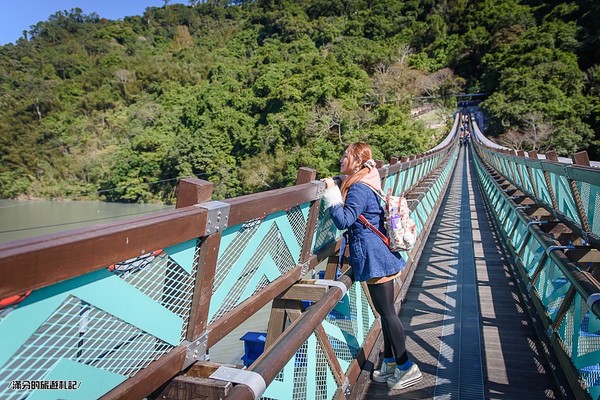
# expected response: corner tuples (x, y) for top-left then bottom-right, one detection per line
(0, 0), (600, 202)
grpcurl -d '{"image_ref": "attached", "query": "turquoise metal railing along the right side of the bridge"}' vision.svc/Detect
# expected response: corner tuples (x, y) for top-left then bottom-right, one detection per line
(473, 120), (600, 399)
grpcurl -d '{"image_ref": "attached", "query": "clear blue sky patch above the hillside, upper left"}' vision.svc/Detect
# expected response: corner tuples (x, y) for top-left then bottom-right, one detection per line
(0, 0), (189, 45)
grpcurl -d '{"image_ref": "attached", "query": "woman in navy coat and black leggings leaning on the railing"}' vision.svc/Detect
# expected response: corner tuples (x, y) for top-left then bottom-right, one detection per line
(324, 142), (422, 389)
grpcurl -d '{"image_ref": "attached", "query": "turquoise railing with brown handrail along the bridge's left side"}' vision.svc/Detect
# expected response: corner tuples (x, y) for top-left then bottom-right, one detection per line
(0, 114), (459, 399)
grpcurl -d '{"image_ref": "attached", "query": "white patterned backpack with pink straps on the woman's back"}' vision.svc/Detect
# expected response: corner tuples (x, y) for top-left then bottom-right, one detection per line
(358, 186), (417, 252)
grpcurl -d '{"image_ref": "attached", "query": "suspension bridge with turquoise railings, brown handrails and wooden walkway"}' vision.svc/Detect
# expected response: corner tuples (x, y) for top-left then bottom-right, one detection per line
(0, 113), (600, 400)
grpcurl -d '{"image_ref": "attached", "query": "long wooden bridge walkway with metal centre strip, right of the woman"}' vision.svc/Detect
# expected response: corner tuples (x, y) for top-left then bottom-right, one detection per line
(351, 150), (561, 400)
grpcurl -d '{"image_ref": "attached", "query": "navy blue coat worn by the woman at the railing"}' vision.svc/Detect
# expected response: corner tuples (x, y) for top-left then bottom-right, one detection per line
(329, 182), (406, 281)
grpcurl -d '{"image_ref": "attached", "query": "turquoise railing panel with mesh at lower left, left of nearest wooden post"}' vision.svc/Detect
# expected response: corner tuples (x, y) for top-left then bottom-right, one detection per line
(0, 240), (198, 399)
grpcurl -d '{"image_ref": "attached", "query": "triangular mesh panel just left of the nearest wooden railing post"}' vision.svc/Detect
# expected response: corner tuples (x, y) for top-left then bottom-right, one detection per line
(112, 245), (200, 340)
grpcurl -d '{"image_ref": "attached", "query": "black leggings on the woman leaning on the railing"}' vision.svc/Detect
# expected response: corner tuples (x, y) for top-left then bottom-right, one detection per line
(367, 280), (408, 365)
